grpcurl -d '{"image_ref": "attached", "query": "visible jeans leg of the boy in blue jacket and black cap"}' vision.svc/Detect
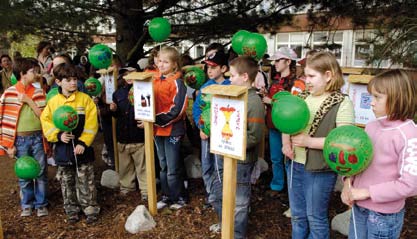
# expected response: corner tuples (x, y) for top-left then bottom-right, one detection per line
(201, 139), (214, 195)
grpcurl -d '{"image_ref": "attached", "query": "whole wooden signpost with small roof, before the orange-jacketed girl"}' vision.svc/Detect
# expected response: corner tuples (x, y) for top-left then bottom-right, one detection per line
(124, 72), (158, 216)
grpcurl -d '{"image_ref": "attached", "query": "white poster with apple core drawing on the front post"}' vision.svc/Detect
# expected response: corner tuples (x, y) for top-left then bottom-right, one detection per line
(210, 96), (246, 160)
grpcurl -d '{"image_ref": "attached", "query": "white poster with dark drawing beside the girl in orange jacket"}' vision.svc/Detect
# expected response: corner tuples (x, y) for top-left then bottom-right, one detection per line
(133, 80), (155, 122)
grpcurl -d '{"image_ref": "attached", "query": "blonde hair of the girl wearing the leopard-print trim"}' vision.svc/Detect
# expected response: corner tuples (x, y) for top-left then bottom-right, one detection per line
(306, 51), (345, 92)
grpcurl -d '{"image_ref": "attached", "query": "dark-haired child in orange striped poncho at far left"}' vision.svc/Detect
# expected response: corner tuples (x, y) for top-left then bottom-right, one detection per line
(0, 58), (48, 217)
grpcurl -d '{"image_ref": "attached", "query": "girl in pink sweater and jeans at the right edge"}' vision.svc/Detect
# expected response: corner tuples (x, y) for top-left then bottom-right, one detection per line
(341, 69), (417, 238)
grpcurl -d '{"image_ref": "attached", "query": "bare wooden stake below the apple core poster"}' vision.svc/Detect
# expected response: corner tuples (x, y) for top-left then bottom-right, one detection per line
(222, 157), (237, 239)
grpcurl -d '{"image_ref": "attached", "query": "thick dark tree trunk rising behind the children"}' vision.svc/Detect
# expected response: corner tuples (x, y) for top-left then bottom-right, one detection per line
(115, 0), (146, 64)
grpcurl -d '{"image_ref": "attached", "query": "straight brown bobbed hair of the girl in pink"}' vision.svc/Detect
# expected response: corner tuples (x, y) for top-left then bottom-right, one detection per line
(368, 69), (417, 120)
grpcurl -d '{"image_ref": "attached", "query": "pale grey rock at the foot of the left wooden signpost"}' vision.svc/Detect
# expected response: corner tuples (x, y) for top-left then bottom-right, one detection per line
(125, 205), (156, 234)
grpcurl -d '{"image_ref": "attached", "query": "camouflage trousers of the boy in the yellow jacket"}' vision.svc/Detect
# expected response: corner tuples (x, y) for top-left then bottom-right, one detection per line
(57, 163), (100, 215)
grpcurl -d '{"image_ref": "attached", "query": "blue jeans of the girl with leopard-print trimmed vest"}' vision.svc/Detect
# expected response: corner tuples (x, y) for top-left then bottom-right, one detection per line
(287, 161), (337, 239)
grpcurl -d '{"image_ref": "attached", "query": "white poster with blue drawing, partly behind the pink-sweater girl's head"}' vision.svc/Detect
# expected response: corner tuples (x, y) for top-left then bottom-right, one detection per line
(349, 83), (375, 125)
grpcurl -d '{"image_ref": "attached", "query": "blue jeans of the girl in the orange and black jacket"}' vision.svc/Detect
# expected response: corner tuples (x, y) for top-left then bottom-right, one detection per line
(155, 136), (186, 202)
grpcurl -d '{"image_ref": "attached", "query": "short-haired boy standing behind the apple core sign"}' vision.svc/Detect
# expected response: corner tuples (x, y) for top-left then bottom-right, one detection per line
(209, 56), (265, 238)
